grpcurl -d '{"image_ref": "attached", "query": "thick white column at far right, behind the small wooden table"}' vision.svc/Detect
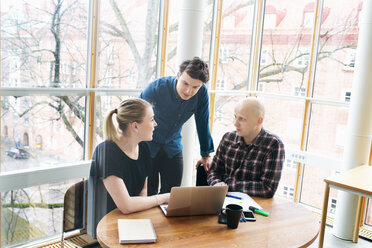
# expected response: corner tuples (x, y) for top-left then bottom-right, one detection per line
(333, 0), (372, 240)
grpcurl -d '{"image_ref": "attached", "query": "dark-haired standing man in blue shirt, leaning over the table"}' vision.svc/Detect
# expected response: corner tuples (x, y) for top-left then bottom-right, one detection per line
(140, 57), (214, 196)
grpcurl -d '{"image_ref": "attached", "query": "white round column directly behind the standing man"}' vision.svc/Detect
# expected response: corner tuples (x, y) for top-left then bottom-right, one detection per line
(177, 0), (205, 186)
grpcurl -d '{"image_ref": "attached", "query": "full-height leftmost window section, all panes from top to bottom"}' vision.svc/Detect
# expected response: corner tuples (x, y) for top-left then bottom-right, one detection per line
(0, 0), (89, 247)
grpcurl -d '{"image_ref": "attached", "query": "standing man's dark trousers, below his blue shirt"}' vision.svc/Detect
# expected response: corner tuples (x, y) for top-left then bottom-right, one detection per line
(147, 149), (183, 196)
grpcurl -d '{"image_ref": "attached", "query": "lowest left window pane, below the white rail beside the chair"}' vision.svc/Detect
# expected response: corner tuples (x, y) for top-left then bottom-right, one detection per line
(1, 180), (83, 247)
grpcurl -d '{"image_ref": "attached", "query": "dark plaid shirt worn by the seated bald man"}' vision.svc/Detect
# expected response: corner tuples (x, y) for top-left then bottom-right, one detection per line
(207, 129), (285, 197)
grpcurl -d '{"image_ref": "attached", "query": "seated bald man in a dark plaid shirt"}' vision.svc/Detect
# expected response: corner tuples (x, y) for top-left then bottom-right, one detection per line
(207, 97), (285, 198)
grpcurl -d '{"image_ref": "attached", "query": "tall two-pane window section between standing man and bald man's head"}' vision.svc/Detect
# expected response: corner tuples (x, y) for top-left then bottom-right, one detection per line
(212, 0), (254, 143)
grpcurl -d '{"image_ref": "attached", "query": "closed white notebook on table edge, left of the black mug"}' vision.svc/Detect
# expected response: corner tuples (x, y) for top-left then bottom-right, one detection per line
(118, 219), (156, 244)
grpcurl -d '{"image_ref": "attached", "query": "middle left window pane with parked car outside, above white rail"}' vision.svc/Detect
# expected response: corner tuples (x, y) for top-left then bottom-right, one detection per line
(0, 95), (85, 172)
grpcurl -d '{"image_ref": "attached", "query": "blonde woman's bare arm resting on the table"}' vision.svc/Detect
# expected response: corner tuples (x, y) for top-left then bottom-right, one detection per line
(103, 176), (169, 214)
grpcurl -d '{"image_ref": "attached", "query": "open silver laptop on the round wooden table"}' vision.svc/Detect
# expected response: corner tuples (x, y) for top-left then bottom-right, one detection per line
(160, 185), (228, 216)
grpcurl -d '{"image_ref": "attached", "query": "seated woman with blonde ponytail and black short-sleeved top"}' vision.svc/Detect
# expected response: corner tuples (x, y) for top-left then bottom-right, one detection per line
(88, 99), (169, 227)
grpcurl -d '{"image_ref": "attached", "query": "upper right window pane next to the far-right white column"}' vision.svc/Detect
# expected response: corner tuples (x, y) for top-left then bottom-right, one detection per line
(314, 0), (360, 101)
